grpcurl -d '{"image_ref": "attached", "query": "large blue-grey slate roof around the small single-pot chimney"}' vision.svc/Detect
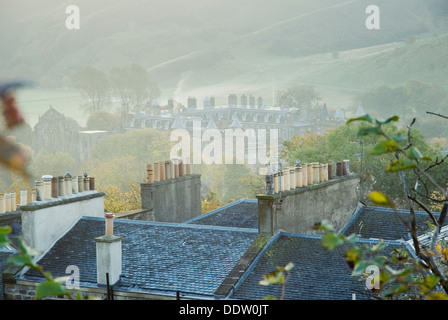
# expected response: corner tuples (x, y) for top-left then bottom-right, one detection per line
(19, 217), (258, 298)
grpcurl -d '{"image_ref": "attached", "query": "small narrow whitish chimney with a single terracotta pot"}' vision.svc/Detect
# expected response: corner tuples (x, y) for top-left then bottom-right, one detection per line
(95, 213), (122, 285)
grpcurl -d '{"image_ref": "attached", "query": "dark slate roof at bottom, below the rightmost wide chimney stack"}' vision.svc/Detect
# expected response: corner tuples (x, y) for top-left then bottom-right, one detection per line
(230, 233), (402, 300)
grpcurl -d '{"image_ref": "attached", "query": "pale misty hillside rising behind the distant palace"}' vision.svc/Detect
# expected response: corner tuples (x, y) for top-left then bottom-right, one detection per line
(0, 0), (448, 96)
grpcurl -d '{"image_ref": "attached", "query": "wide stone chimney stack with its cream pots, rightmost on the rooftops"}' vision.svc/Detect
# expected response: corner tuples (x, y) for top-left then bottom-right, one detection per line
(257, 162), (359, 234)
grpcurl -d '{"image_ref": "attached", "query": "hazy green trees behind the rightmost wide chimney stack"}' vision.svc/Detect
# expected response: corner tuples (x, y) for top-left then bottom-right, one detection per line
(280, 123), (448, 207)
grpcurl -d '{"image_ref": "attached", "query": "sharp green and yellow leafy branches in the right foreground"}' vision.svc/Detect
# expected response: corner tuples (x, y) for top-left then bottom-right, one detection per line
(316, 115), (448, 300)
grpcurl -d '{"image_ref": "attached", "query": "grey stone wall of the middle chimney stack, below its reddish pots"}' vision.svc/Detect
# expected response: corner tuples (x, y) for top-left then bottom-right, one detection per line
(140, 174), (201, 223)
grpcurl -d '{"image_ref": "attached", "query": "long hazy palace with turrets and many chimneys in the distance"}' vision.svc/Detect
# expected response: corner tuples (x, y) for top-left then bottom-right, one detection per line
(123, 94), (346, 144)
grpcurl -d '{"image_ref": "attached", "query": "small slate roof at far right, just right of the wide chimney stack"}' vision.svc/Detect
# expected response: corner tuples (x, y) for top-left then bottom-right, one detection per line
(341, 206), (448, 241)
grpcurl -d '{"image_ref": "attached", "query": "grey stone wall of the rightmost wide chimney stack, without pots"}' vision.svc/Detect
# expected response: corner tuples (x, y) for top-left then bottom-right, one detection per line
(257, 174), (359, 234)
